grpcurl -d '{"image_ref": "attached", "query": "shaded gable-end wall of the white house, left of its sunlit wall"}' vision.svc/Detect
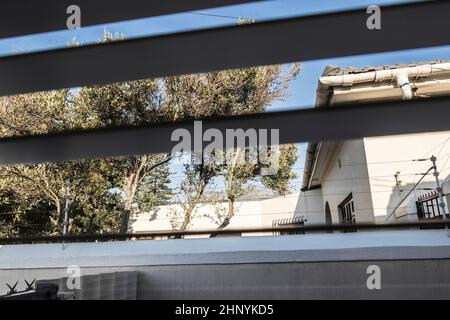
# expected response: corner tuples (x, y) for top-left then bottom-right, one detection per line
(321, 139), (373, 223)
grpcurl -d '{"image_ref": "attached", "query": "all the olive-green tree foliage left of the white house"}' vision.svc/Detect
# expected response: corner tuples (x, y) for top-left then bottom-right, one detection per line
(0, 32), (299, 236)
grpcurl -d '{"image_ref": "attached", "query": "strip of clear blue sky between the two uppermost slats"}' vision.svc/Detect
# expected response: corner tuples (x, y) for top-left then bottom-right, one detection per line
(0, 0), (418, 55)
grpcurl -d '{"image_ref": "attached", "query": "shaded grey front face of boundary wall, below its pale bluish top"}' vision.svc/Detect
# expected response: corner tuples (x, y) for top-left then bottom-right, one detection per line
(7, 259), (450, 300)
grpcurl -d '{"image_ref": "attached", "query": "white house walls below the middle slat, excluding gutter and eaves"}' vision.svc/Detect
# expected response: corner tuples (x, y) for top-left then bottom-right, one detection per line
(296, 131), (450, 223)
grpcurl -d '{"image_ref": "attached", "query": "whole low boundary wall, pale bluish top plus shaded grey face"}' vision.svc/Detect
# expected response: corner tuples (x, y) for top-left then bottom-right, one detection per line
(0, 230), (450, 299)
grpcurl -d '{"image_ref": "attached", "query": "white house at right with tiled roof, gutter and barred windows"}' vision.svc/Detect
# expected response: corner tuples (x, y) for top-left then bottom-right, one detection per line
(296, 61), (450, 224)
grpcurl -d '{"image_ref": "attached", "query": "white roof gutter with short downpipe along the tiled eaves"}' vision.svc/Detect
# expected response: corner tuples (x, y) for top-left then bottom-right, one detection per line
(319, 63), (450, 100)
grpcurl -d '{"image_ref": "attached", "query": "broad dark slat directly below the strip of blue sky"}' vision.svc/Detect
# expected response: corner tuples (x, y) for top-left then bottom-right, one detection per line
(0, 1), (450, 95)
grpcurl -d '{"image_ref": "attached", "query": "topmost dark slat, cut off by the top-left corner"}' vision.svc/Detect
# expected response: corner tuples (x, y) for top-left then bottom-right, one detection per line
(0, 0), (261, 38)
